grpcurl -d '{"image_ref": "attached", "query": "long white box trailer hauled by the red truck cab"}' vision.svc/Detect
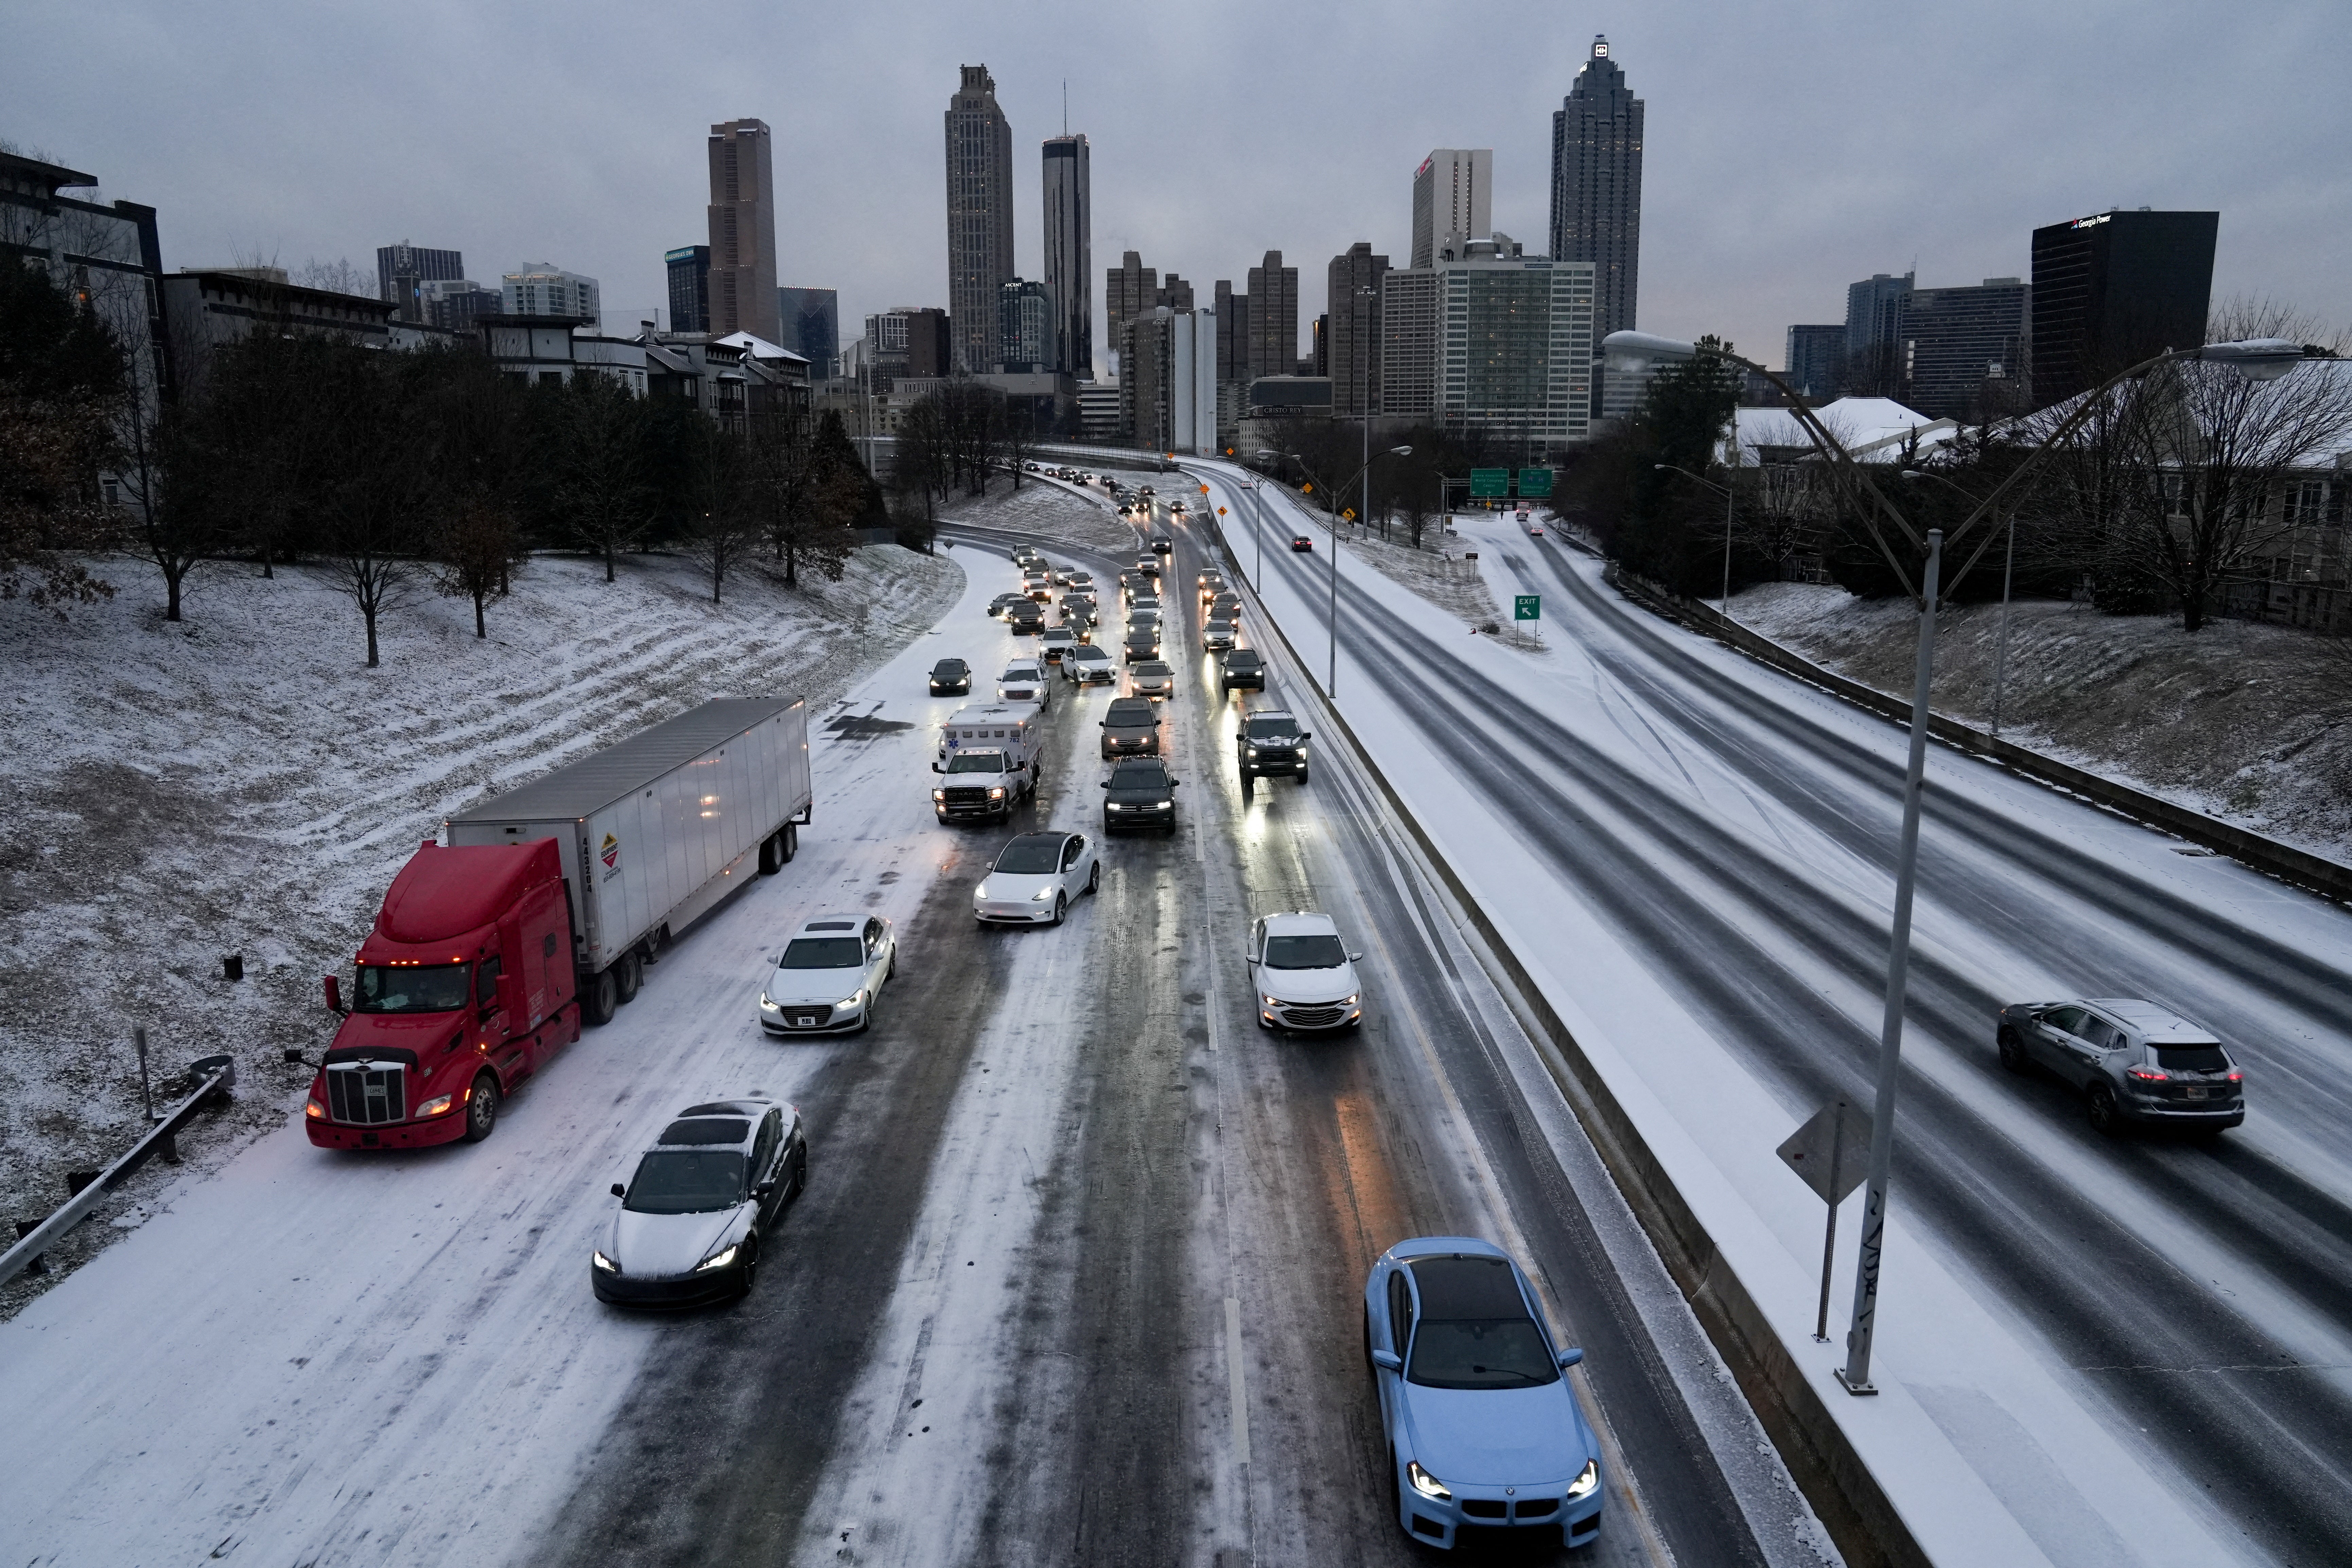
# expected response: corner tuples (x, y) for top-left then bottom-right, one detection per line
(449, 696), (812, 1023)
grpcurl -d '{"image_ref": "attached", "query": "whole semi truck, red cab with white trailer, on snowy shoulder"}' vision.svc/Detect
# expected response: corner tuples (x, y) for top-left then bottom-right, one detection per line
(287, 698), (809, 1150)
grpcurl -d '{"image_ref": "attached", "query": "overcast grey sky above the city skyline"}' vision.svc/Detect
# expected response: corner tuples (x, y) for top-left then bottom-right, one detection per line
(0, 0), (2352, 364)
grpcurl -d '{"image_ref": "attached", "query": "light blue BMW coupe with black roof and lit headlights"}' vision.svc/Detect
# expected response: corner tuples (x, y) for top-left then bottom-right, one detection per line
(1364, 1237), (1602, 1547)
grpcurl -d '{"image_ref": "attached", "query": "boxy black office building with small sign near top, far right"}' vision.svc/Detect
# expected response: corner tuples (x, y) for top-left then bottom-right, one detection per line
(2032, 209), (2220, 407)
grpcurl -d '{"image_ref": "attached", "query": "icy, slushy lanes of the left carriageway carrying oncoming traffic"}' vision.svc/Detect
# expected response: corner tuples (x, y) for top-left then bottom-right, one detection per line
(0, 531), (1823, 1566)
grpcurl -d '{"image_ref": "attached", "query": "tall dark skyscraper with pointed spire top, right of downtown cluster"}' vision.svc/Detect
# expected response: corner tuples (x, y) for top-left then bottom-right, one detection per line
(1550, 38), (1642, 357)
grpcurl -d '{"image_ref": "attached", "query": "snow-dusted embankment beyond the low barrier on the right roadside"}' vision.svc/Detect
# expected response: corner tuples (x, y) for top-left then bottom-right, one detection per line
(1731, 583), (2352, 860)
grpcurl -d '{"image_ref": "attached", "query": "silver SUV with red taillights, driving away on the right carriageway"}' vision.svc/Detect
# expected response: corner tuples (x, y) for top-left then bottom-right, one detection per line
(1994, 997), (2246, 1135)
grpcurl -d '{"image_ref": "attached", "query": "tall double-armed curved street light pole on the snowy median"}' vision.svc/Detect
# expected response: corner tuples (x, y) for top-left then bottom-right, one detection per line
(1602, 331), (2319, 1394)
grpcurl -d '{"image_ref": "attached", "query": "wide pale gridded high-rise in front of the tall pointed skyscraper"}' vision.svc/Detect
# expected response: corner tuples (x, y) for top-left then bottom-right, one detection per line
(1432, 235), (1599, 463)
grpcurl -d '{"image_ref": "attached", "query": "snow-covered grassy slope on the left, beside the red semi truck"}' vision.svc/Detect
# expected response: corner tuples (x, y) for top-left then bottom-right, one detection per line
(0, 545), (962, 1314)
